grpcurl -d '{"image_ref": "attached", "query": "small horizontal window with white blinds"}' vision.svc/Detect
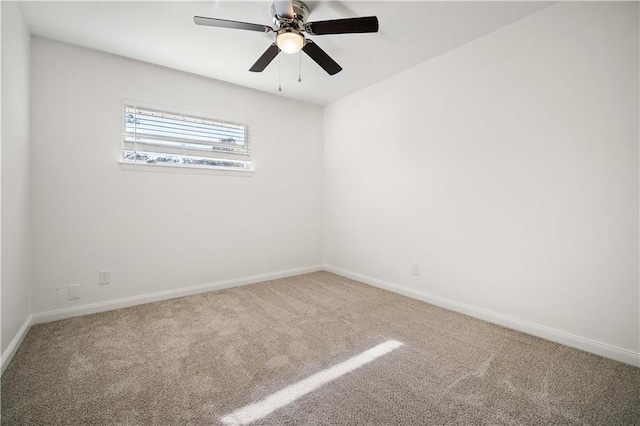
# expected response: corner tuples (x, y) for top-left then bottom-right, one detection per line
(122, 105), (252, 170)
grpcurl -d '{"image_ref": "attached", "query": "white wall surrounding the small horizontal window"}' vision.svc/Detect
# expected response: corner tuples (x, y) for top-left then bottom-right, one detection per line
(31, 38), (322, 313)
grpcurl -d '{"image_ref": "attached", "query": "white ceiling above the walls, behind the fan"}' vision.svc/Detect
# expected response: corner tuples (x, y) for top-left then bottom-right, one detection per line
(20, 1), (550, 105)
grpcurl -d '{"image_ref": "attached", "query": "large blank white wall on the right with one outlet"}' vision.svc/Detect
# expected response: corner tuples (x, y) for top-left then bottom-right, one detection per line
(324, 2), (639, 353)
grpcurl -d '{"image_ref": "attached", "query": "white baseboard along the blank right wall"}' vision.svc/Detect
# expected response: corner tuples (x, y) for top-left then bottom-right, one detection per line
(324, 264), (640, 367)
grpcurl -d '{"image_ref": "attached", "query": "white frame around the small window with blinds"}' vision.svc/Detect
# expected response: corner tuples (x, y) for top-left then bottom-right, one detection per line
(120, 98), (254, 174)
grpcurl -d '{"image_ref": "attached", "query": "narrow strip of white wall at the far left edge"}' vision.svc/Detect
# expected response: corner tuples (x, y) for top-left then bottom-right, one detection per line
(0, 1), (31, 354)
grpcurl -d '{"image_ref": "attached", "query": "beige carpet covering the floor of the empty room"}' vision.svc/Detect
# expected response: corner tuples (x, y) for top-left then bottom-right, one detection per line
(2, 272), (640, 425)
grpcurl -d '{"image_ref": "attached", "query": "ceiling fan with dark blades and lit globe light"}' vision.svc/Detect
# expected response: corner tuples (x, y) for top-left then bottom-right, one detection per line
(193, 0), (378, 75)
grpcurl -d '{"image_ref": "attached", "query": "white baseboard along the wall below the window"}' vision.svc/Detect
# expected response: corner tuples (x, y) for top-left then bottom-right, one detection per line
(31, 265), (323, 324)
